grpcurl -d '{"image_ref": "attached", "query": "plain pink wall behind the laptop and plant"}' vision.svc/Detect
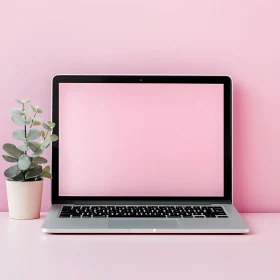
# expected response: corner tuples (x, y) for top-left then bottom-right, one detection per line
(0, 0), (280, 212)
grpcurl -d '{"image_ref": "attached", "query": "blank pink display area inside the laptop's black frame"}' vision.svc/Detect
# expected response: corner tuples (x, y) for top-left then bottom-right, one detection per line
(59, 83), (224, 196)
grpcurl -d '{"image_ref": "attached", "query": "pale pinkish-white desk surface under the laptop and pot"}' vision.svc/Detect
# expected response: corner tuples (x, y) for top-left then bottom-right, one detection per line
(0, 213), (280, 280)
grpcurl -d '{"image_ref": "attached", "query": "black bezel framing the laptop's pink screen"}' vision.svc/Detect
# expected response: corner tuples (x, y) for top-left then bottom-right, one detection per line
(51, 75), (232, 204)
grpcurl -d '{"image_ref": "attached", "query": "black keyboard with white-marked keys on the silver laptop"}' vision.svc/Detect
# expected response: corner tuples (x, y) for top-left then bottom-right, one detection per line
(59, 205), (228, 218)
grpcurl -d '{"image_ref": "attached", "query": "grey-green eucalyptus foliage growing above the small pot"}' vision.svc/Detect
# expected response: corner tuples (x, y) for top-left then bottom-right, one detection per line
(3, 99), (58, 181)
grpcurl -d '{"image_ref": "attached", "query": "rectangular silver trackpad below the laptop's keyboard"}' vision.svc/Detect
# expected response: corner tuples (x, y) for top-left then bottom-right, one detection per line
(108, 218), (179, 229)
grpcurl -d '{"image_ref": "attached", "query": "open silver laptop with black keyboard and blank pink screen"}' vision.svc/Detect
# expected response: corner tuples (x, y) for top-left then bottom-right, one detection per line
(42, 75), (249, 233)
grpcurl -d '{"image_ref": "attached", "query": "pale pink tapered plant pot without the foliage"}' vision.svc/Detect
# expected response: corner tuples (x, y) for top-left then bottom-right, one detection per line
(6, 180), (43, 220)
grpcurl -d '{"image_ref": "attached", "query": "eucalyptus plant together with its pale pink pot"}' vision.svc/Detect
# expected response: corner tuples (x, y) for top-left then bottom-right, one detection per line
(3, 99), (58, 219)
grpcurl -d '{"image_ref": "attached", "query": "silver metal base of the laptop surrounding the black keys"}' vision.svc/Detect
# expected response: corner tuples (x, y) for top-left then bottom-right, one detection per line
(42, 204), (249, 234)
